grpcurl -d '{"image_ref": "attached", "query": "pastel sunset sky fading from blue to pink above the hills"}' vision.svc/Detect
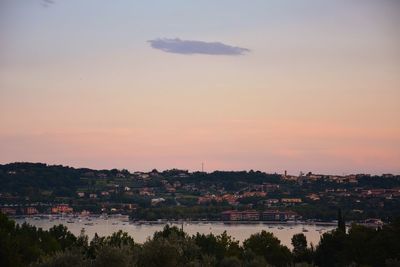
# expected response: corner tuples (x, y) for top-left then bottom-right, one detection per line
(0, 0), (400, 175)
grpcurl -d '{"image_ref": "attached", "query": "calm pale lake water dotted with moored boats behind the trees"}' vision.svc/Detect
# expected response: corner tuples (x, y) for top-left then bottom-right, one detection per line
(16, 218), (334, 248)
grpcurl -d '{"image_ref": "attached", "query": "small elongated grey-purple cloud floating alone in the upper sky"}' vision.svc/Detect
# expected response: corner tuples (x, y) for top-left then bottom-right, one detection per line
(148, 38), (250, 56)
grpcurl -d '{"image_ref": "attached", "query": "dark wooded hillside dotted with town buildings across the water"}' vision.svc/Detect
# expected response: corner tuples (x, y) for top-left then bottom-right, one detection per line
(0, 163), (400, 224)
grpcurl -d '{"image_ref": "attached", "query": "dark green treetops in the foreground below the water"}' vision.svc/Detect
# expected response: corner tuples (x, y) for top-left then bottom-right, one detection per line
(0, 214), (400, 267)
